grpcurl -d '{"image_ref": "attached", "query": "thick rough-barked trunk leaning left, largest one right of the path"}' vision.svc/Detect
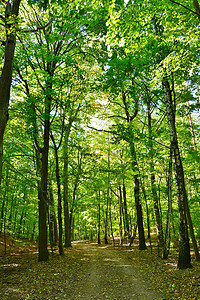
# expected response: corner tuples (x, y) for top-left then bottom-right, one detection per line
(163, 75), (191, 269)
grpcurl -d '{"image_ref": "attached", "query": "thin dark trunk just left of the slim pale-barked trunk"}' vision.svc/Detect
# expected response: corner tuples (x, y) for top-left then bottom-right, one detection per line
(147, 99), (163, 245)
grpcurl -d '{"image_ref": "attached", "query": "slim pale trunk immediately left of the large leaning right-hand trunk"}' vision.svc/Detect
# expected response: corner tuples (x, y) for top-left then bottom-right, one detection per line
(163, 149), (172, 259)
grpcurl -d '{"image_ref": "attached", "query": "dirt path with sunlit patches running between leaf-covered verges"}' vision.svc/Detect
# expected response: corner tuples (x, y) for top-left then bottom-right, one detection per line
(71, 244), (163, 300)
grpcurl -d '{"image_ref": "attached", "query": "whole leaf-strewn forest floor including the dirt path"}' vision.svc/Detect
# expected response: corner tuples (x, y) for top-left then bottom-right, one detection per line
(0, 238), (200, 300)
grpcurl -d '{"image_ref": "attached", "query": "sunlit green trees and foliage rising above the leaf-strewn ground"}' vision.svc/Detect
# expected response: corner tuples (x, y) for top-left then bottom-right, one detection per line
(0, 0), (200, 299)
